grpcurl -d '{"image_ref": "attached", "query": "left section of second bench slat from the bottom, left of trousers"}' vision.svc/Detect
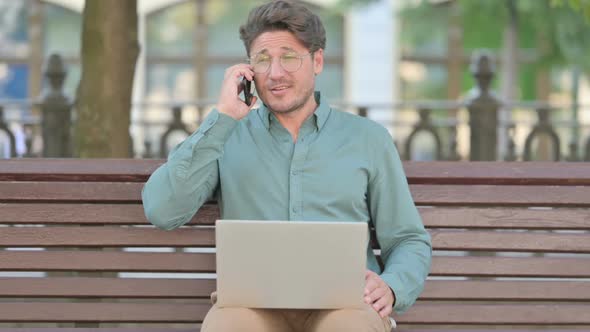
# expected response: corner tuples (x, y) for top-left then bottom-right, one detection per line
(0, 302), (211, 323)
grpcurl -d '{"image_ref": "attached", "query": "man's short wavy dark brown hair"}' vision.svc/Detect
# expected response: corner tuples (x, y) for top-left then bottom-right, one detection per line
(240, 0), (326, 56)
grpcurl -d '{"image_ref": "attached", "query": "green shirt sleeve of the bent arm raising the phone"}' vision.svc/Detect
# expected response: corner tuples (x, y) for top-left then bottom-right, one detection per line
(141, 110), (238, 230)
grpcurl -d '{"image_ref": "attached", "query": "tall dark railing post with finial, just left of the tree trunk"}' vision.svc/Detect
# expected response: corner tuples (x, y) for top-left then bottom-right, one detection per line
(41, 54), (72, 157)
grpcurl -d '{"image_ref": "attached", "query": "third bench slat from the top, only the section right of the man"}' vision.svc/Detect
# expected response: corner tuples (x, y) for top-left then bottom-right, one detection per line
(419, 207), (590, 230)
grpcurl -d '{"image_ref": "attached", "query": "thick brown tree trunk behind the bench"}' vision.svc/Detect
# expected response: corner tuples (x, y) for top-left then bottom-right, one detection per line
(74, 0), (139, 158)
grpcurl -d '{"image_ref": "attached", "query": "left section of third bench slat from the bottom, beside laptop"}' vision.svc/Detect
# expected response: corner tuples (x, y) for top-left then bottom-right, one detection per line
(0, 277), (216, 299)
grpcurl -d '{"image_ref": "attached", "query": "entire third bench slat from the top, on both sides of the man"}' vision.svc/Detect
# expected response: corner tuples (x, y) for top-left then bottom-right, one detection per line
(0, 203), (590, 230)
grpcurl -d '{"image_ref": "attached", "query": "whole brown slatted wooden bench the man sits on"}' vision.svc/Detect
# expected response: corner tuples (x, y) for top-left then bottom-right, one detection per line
(0, 159), (590, 332)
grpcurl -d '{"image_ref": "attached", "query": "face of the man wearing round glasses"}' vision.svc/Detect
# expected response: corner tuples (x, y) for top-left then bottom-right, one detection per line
(250, 31), (324, 113)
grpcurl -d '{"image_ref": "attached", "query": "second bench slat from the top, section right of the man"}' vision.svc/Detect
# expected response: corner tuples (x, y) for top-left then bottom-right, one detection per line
(410, 185), (590, 207)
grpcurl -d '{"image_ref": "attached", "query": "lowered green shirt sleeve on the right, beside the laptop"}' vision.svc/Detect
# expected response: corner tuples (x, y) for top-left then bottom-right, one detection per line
(368, 127), (432, 313)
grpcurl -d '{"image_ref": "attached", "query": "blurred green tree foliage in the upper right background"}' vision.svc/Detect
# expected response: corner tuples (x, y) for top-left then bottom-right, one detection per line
(401, 0), (590, 99)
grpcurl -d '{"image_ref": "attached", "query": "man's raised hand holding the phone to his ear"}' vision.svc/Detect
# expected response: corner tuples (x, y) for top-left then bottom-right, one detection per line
(217, 64), (257, 120)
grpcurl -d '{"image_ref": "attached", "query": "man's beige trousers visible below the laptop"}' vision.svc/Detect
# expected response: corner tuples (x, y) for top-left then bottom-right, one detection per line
(201, 305), (391, 332)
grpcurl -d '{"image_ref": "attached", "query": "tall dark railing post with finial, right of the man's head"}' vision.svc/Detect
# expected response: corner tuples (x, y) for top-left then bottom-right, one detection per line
(466, 52), (501, 161)
